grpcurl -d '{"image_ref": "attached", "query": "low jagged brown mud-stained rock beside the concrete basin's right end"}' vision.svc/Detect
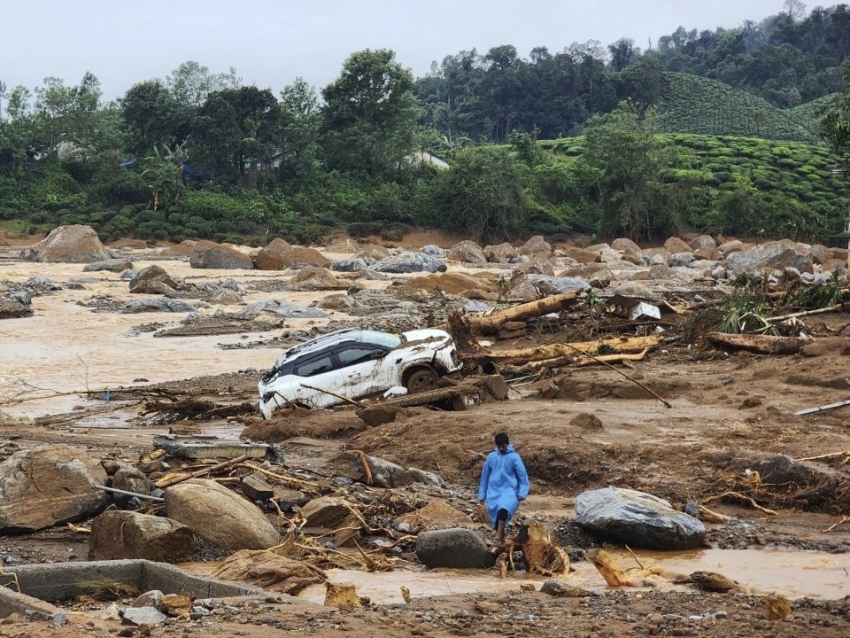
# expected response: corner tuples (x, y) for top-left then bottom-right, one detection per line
(211, 549), (328, 596)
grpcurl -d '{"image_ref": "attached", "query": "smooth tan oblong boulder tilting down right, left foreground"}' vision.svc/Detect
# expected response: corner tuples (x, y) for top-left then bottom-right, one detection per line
(165, 479), (280, 550)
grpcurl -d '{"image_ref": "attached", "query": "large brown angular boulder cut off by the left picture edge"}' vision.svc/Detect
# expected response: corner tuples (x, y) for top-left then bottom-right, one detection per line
(0, 445), (106, 534)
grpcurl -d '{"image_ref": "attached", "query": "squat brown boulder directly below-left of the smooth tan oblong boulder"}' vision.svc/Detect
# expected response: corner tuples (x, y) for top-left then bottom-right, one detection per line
(89, 510), (197, 563)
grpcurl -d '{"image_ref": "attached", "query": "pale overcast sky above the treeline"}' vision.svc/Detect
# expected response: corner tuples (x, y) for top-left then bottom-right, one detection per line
(0, 0), (784, 99)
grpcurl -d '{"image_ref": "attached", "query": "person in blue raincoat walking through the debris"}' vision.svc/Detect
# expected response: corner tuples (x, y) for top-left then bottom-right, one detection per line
(478, 432), (528, 543)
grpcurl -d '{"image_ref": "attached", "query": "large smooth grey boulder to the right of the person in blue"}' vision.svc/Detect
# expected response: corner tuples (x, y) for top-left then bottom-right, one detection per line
(575, 487), (705, 549)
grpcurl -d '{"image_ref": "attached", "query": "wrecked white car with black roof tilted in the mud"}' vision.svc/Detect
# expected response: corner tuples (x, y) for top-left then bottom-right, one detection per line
(259, 329), (461, 419)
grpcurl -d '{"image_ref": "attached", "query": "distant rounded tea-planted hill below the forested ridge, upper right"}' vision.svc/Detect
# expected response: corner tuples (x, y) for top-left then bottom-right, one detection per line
(661, 73), (819, 143)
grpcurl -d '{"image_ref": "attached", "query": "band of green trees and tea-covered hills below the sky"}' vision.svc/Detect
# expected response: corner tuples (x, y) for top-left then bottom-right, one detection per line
(0, 5), (850, 248)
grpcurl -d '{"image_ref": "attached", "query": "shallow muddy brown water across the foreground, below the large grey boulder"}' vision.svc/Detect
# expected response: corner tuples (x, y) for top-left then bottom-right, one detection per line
(299, 549), (850, 604)
